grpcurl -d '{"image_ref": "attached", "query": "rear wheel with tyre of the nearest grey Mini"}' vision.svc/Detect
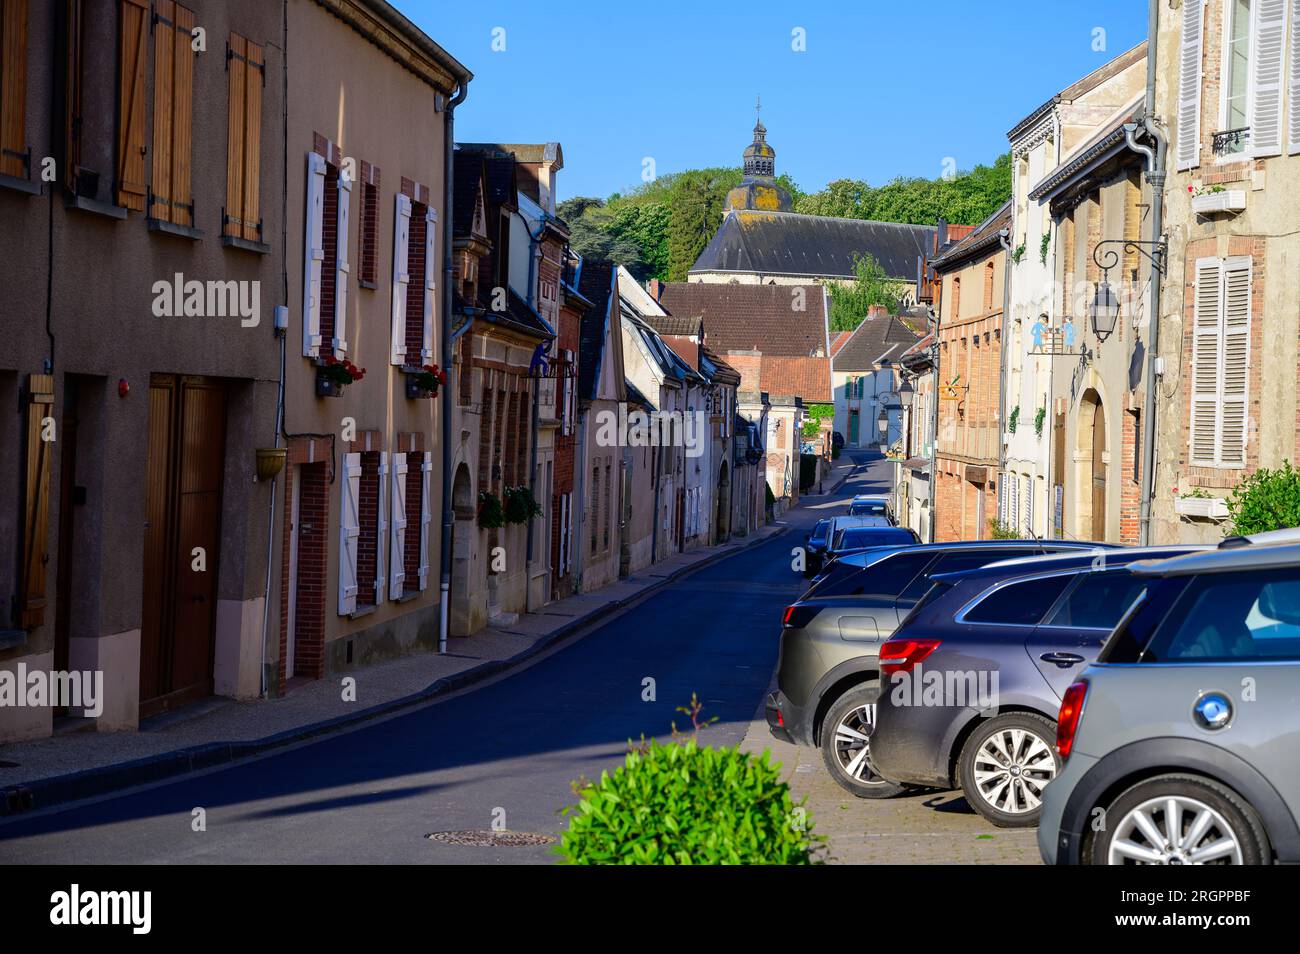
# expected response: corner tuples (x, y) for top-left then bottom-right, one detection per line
(1084, 775), (1271, 864)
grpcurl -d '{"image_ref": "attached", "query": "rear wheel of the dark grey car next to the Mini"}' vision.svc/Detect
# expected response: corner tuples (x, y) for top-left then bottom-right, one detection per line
(959, 712), (1061, 828)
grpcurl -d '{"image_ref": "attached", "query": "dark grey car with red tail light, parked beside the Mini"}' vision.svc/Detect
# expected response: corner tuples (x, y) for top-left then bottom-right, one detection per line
(870, 546), (1208, 828)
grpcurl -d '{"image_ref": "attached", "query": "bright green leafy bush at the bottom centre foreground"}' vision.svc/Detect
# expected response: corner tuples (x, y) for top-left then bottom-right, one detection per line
(555, 738), (820, 864)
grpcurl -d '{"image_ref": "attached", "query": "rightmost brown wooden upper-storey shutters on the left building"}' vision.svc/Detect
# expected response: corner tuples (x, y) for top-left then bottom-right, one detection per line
(221, 32), (267, 244)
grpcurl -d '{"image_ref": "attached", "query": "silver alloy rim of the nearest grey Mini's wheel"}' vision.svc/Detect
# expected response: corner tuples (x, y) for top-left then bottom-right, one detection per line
(1108, 795), (1244, 864)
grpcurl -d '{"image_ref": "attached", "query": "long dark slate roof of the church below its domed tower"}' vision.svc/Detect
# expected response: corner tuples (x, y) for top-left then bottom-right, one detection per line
(690, 209), (935, 282)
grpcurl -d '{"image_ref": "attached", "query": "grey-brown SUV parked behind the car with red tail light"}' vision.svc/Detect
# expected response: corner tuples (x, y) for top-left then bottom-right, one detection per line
(766, 541), (1112, 798)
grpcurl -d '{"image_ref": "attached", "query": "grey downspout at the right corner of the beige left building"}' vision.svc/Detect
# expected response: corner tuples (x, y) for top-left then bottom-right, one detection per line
(438, 77), (471, 654)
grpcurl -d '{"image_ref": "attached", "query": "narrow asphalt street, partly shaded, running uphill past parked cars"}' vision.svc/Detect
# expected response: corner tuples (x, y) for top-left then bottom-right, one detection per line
(0, 455), (889, 863)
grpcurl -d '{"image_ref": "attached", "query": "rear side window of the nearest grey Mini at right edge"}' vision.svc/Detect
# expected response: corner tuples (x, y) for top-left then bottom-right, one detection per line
(1141, 568), (1300, 662)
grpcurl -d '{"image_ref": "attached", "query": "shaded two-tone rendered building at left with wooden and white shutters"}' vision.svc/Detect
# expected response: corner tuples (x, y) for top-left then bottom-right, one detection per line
(0, 0), (469, 741)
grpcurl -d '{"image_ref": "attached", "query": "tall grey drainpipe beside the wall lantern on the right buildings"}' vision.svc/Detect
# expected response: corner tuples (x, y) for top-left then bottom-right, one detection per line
(1125, 0), (1169, 546)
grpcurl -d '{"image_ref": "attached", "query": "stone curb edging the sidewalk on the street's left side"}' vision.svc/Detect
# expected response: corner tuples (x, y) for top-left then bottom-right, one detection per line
(0, 526), (790, 827)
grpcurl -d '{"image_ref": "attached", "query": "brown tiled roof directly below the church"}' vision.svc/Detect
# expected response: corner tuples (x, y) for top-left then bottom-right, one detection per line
(659, 282), (827, 357)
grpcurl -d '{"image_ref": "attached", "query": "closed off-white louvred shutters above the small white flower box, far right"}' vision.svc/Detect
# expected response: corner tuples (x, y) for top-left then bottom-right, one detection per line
(1190, 256), (1252, 468)
